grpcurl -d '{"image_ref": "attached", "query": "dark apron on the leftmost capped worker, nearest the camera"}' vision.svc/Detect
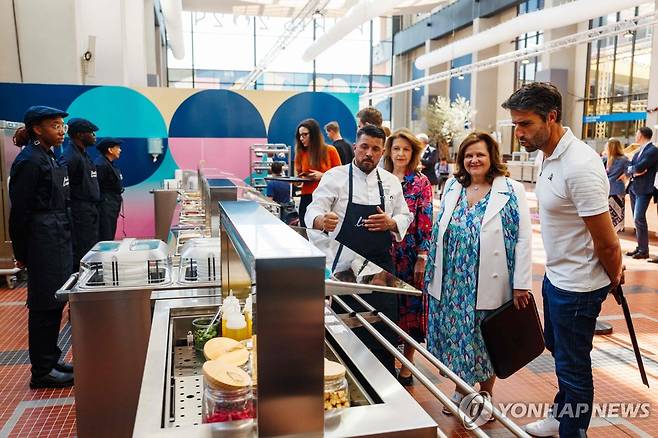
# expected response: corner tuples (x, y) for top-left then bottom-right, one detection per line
(27, 154), (73, 310)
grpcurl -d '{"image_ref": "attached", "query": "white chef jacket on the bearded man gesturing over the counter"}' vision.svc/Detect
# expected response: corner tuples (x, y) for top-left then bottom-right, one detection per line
(304, 162), (413, 269)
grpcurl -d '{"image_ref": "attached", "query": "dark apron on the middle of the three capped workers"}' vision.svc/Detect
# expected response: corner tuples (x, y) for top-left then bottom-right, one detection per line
(71, 149), (100, 270)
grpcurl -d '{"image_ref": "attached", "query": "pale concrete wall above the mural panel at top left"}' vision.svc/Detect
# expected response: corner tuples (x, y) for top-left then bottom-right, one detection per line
(0, 0), (154, 87)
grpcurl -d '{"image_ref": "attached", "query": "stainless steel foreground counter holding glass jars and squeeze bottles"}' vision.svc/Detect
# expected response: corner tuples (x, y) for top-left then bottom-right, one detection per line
(133, 291), (437, 438)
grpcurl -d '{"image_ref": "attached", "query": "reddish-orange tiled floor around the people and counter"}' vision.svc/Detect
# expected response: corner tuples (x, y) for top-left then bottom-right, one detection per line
(0, 191), (658, 437)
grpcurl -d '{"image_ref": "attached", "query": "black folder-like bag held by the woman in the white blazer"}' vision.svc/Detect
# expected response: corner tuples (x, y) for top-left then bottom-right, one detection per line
(480, 294), (544, 379)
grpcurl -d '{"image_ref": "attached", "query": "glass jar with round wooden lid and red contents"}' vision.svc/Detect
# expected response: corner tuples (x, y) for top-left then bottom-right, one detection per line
(202, 360), (256, 423)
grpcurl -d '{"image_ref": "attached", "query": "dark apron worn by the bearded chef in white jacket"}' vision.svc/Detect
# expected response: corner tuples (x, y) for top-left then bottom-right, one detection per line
(332, 164), (398, 373)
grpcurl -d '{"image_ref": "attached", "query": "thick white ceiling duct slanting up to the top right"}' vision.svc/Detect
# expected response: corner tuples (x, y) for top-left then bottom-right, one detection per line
(415, 0), (648, 70)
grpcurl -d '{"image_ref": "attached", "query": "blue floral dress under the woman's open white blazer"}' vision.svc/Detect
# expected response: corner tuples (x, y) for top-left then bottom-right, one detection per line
(427, 188), (494, 385)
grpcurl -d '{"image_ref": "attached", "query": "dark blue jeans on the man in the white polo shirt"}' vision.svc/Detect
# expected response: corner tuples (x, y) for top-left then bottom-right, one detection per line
(542, 276), (610, 438)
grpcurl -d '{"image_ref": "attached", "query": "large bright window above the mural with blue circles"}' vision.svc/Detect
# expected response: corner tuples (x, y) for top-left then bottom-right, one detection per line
(167, 11), (393, 120)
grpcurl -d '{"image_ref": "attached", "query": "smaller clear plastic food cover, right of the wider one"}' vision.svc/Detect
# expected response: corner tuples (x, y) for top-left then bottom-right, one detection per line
(178, 237), (221, 283)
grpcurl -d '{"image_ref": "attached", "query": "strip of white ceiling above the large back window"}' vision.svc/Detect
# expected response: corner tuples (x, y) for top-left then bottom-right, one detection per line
(183, 0), (453, 18)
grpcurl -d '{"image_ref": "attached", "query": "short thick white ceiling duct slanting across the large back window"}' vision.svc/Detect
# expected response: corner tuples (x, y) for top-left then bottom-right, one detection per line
(302, 0), (402, 62)
